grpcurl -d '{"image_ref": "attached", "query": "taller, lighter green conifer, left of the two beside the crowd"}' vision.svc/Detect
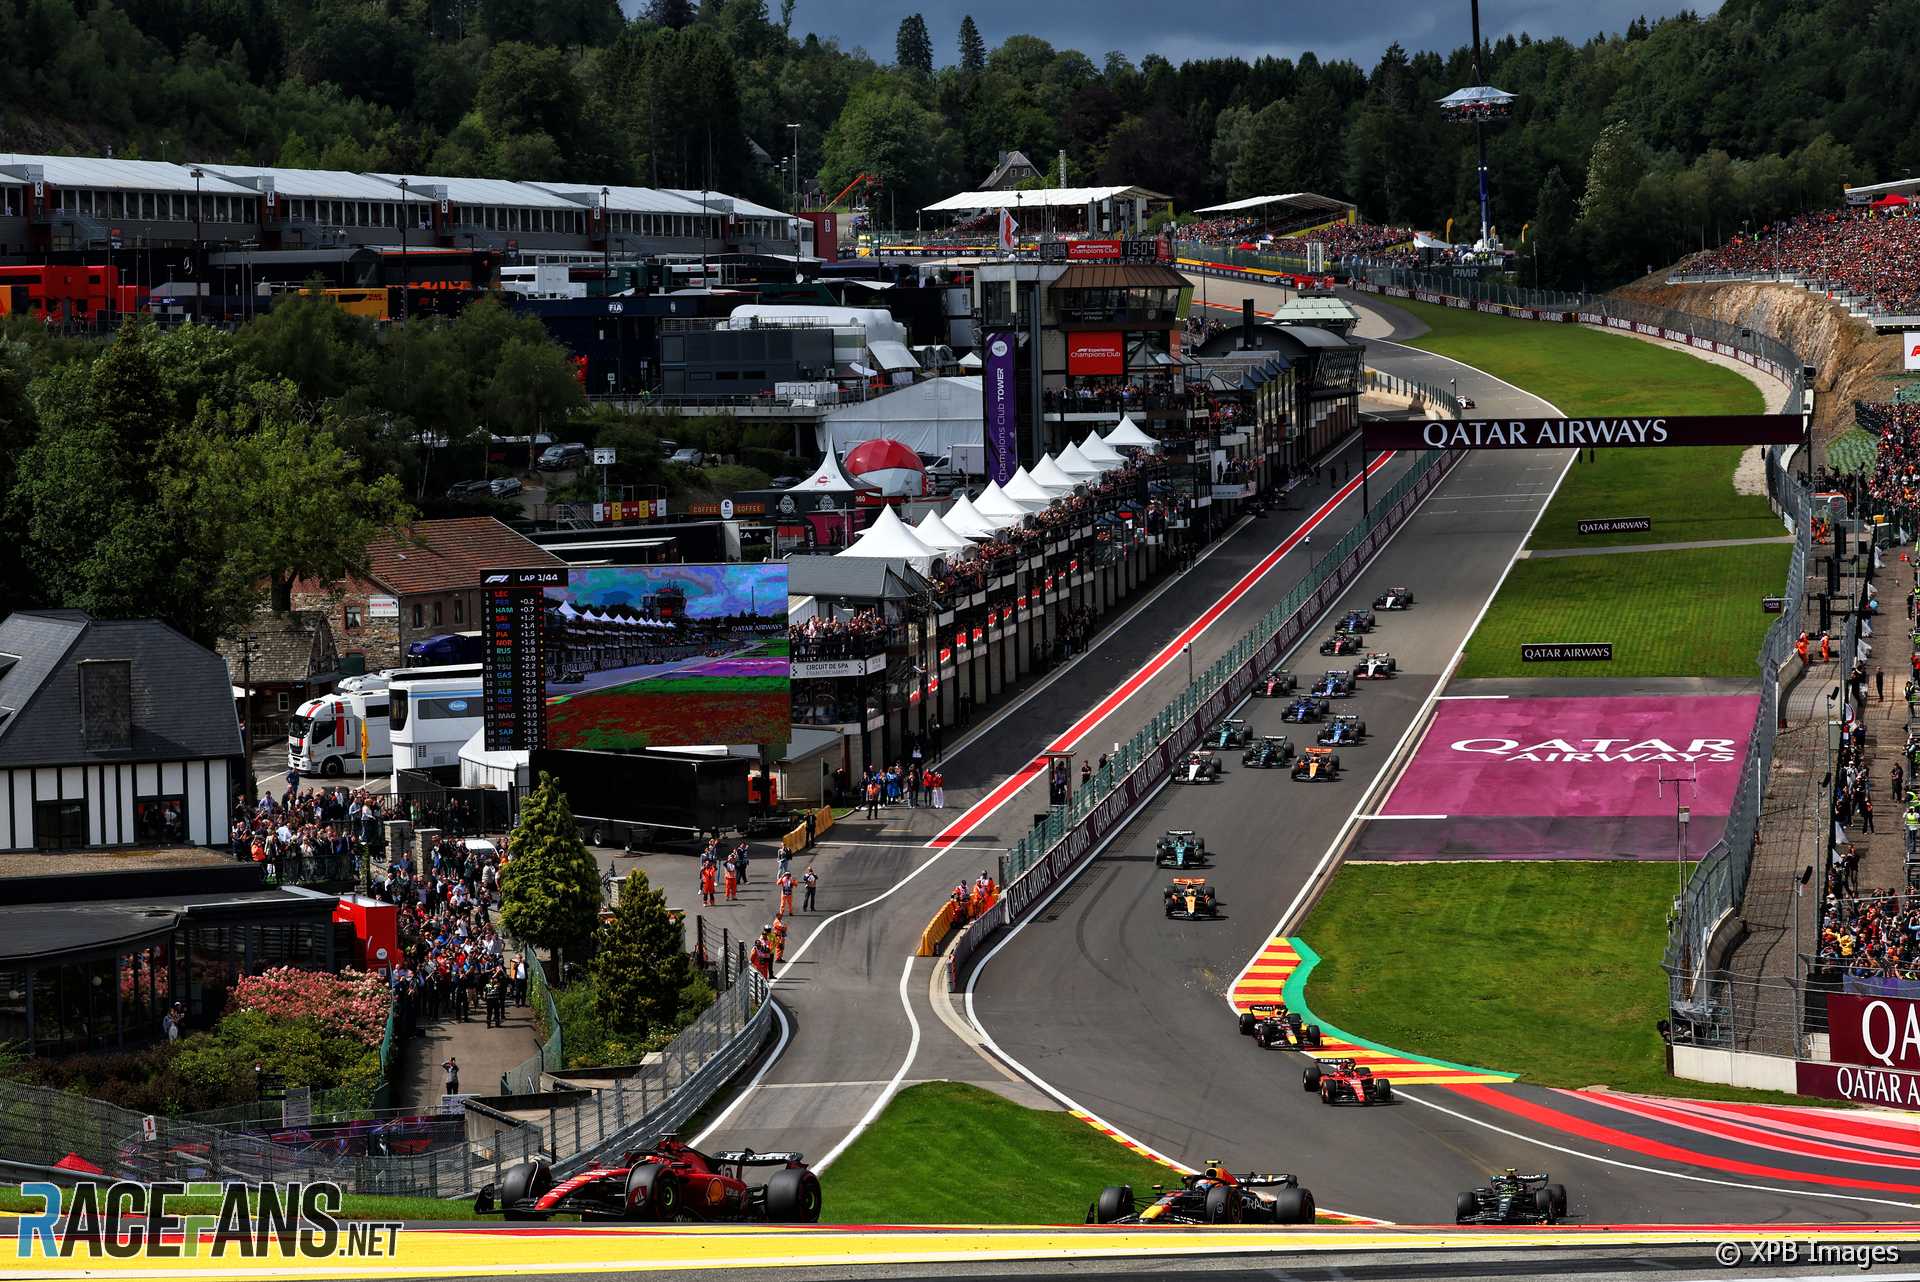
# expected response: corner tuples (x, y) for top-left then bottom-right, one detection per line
(499, 772), (599, 950)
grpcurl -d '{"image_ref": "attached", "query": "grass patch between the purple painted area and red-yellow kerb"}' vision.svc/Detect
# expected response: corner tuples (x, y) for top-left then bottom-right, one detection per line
(1300, 862), (1805, 1104)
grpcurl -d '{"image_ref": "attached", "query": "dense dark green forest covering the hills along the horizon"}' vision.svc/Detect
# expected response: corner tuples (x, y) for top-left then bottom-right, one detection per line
(0, 0), (1920, 284)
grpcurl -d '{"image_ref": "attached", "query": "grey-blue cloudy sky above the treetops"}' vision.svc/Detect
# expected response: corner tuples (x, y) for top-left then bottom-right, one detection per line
(787, 0), (1720, 67)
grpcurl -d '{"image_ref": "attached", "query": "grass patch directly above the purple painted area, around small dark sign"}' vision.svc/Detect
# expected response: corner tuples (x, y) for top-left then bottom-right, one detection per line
(1457, 543), (1793, 677)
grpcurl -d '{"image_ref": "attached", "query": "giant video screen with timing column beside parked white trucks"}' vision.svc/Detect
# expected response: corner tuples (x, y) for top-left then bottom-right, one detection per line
(484, 560), (793, 752)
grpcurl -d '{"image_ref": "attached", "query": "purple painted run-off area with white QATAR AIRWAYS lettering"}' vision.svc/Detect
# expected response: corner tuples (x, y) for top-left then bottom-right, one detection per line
(1357, 695), (1759, 860)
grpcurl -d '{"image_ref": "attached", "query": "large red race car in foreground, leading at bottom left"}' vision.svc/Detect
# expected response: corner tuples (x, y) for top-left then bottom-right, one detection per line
(474, 1140), (820, 1224)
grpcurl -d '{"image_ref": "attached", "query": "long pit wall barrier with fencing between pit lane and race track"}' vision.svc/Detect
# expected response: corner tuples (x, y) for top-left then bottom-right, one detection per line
(947, 451), (1463, 990)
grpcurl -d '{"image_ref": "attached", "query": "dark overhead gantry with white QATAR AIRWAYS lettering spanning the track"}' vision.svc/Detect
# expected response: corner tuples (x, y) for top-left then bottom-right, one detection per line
(1359, 415), (1805, 449)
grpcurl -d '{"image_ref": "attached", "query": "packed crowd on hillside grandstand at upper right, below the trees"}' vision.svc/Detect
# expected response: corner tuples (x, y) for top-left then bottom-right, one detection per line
(1682, 207), (1920, 313)
